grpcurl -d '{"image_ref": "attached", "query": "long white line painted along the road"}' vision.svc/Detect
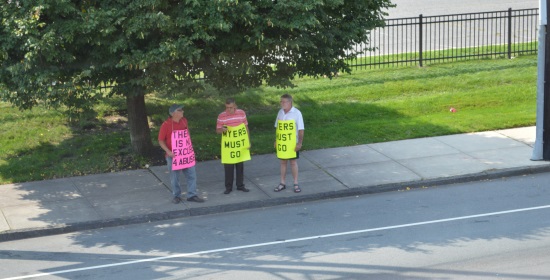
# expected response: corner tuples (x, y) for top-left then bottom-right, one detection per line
(4, 205), (550, 280)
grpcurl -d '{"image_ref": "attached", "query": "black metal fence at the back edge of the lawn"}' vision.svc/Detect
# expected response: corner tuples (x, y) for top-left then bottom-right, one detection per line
(350, 8), (539, 69)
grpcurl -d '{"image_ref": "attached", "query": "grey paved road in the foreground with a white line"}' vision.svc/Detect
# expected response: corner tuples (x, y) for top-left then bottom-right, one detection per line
(0, 174), (550, 280)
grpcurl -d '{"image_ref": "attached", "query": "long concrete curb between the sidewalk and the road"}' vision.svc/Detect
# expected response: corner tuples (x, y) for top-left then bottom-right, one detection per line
(0, 165), (550, 242)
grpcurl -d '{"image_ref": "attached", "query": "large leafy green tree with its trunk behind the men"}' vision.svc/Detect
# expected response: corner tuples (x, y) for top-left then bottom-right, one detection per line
(0, 0), (392, 155)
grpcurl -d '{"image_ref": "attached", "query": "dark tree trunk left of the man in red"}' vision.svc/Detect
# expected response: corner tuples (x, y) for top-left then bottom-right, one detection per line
(126, 94), (153, 157)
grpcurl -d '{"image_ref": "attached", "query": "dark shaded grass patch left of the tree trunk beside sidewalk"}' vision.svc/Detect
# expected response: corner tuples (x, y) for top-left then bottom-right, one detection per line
(0, 132), (149, 185)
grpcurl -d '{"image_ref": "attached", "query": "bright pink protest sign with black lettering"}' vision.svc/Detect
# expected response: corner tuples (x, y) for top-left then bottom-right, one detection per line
(172, 129), (199, 170)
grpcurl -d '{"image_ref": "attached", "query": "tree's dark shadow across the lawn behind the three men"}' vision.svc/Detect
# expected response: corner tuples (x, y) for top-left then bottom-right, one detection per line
(0, 92), (464, 185)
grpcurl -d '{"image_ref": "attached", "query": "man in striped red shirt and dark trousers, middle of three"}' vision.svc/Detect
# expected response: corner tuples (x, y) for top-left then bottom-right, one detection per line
(216, 98), (250, 194)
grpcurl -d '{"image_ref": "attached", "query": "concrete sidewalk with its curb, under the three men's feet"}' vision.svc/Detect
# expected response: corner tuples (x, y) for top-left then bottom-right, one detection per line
(0, 127), (550, 241)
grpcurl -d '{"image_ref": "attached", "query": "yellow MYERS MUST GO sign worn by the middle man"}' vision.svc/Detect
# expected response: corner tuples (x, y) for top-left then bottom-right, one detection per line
(221, 124), (250, 164)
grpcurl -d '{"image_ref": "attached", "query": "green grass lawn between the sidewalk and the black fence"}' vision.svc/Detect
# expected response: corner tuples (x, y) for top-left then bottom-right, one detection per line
(0, 55), (537, 184)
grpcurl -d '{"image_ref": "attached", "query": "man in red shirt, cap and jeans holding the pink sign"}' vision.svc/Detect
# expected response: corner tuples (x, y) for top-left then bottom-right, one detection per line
(158, 104), (204, 204)
